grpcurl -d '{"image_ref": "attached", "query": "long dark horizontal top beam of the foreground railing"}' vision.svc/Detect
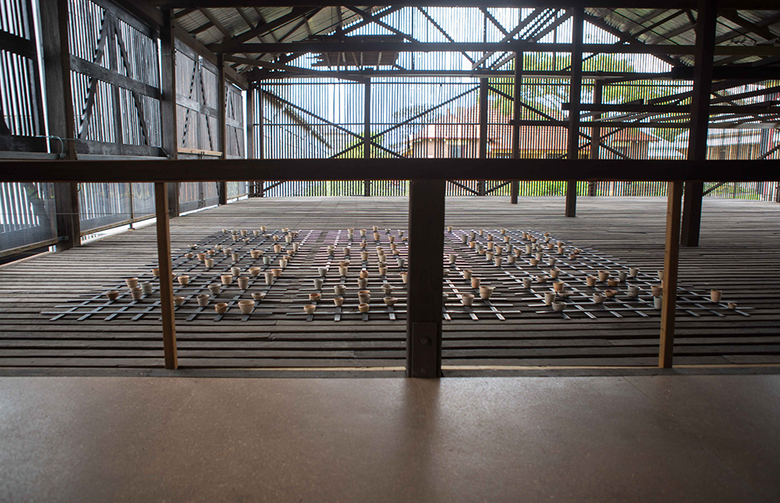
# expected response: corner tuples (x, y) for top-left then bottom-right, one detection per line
(0, 159), (780, 183)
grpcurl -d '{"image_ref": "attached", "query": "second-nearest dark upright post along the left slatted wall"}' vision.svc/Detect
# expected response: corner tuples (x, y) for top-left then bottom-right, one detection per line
(160, 9), (179, 218)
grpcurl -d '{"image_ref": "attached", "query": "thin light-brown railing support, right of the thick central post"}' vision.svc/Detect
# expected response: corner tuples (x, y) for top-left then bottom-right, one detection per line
(658, 182), (682, 368)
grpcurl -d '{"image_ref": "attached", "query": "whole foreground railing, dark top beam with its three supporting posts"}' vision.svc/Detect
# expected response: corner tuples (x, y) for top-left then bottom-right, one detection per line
(0, 159), (780, 377)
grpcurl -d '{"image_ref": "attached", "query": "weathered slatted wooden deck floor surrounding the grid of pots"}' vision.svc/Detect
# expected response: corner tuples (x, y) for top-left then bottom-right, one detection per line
(0, 198), (780, 369)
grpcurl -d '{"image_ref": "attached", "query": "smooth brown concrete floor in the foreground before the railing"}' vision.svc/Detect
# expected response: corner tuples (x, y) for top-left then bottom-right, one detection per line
(0, 375), (780, 503)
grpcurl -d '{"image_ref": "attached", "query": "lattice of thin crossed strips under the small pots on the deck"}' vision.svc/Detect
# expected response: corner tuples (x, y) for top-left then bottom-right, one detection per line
(43, 229), (750, 322)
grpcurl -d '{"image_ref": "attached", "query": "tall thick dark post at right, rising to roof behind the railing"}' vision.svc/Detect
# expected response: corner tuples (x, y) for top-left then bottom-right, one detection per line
(681, 0), (718, 246)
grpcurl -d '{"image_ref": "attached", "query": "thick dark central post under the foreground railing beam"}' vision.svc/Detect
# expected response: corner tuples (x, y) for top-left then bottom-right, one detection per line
(406, 180), (446, 377)
